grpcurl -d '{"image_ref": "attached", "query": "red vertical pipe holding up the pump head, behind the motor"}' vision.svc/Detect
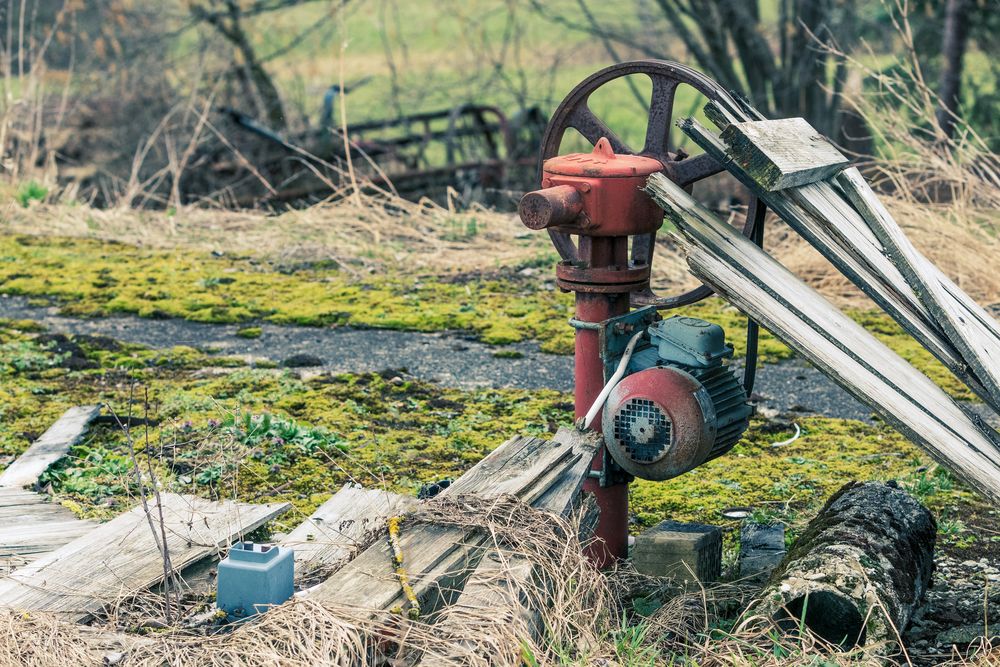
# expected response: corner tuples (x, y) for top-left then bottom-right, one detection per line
(574, 238), (629, 568)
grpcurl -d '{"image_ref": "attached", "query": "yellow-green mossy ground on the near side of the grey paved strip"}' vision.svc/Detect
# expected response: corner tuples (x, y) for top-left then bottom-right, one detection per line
(0, 321), (997, 549)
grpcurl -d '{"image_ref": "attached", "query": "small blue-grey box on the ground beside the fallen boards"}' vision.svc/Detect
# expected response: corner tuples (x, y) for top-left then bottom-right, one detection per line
(216, 542), (295, 617)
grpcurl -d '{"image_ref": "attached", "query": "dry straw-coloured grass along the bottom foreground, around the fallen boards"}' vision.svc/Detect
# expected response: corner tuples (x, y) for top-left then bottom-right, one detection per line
(0, 490), (997, 667)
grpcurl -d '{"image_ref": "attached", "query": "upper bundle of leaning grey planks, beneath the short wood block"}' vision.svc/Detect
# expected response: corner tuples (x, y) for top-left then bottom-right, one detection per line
(680, 105), (1000, 418)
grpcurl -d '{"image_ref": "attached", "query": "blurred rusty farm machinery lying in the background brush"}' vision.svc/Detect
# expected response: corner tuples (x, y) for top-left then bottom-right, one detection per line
(210, 93), (545, 208)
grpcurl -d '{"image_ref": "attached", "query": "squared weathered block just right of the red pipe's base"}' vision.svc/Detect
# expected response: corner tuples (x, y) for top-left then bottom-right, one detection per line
(632, 521), (722, 583)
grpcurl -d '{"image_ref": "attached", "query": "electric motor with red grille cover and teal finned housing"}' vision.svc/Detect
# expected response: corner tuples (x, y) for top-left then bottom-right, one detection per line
(603, 317), (753, 480)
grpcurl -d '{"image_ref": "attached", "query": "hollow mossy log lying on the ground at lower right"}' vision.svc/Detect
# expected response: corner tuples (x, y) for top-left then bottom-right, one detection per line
(748, 482), (937, 653)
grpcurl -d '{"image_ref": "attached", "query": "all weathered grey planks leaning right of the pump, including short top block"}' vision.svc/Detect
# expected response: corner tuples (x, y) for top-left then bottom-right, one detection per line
(647, 100), (1000, 502)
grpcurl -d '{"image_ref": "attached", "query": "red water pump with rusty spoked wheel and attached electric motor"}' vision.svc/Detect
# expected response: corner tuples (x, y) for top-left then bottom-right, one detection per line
(518, 60), (765, 567)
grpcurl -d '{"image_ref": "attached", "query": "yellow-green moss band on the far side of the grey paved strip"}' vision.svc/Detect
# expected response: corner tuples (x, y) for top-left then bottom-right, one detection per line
(0, 236), (970, 398)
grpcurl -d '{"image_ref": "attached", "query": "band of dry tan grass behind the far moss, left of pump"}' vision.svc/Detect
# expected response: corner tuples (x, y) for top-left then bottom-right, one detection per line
(0, 195), (550, 271)
